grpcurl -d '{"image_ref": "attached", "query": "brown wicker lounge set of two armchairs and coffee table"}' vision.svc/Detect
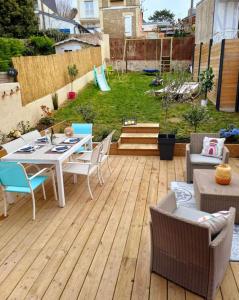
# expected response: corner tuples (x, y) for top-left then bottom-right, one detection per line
(150, 134), (236, 300)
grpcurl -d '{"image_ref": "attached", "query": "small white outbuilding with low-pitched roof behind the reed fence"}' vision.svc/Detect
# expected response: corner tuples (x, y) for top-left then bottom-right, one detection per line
(54, 37), (99, 53)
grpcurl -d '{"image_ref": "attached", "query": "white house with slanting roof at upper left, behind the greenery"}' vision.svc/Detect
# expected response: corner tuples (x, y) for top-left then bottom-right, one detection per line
(35, 0), (88, 34)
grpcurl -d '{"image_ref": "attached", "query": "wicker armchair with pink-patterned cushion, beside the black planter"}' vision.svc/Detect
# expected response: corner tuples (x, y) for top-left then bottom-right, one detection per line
(186, 133), (229, 183)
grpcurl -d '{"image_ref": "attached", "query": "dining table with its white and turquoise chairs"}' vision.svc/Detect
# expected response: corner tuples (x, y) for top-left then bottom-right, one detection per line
(0, 124), (114, 219)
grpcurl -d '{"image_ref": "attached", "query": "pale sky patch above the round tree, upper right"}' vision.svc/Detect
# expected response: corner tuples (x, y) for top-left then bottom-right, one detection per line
(143, 0), (200, 19)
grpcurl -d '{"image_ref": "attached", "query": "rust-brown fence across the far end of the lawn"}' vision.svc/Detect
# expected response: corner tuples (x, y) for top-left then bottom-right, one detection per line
(110, 37), (194, 61)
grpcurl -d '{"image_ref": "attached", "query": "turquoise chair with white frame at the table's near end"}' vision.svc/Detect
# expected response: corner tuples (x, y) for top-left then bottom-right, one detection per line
(0, 162), (57, 220)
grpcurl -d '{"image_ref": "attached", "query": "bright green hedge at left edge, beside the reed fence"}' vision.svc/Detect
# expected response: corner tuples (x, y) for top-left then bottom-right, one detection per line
(0, 38), (26, 72)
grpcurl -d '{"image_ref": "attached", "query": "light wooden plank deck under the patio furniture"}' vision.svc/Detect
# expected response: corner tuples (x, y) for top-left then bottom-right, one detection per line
(0, 156), (239, 300)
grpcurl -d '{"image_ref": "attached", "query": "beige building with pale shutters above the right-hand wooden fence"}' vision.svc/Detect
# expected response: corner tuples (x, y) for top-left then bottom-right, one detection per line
(195, 0), (239, 44)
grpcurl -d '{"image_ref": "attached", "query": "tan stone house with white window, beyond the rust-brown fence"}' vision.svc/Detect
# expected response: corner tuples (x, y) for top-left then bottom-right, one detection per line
(100, 0), (143, 38)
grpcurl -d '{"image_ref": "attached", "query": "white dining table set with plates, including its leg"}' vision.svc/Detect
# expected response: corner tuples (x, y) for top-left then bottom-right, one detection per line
(1, 134), (92, 207)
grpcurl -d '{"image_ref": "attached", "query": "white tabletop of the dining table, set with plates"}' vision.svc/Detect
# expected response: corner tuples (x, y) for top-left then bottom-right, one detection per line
(1, 134), (92, 164)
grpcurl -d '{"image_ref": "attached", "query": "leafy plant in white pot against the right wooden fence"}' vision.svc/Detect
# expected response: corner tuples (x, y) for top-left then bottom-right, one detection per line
(199, 67), (215, 106)
